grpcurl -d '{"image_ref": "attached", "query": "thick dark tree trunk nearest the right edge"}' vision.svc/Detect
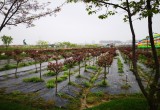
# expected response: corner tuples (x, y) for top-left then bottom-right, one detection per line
(147, 0), (160, 110)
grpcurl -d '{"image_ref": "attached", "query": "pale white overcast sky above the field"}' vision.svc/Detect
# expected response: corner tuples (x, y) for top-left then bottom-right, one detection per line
(0, 0), (160, 45)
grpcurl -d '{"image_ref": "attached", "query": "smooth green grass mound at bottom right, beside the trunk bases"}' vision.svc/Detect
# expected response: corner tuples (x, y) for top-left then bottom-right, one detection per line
(86, 97), (148, 110)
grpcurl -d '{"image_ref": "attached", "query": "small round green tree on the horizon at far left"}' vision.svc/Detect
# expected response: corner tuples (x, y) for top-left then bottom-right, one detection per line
(1, 35), (13, 50)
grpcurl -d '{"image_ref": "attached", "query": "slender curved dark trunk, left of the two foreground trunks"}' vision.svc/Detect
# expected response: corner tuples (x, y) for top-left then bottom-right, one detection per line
(126, 0), (148, 99)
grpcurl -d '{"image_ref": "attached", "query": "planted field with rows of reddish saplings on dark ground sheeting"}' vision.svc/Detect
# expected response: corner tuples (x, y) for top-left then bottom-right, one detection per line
(0, 48), (155, 110)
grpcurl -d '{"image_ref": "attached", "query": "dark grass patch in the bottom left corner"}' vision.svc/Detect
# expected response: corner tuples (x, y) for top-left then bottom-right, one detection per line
(0, 91), (56, 110)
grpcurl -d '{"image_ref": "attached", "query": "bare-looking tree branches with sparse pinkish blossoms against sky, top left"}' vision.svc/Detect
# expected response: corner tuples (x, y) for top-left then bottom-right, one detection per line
(0, 0), (63, 32)
